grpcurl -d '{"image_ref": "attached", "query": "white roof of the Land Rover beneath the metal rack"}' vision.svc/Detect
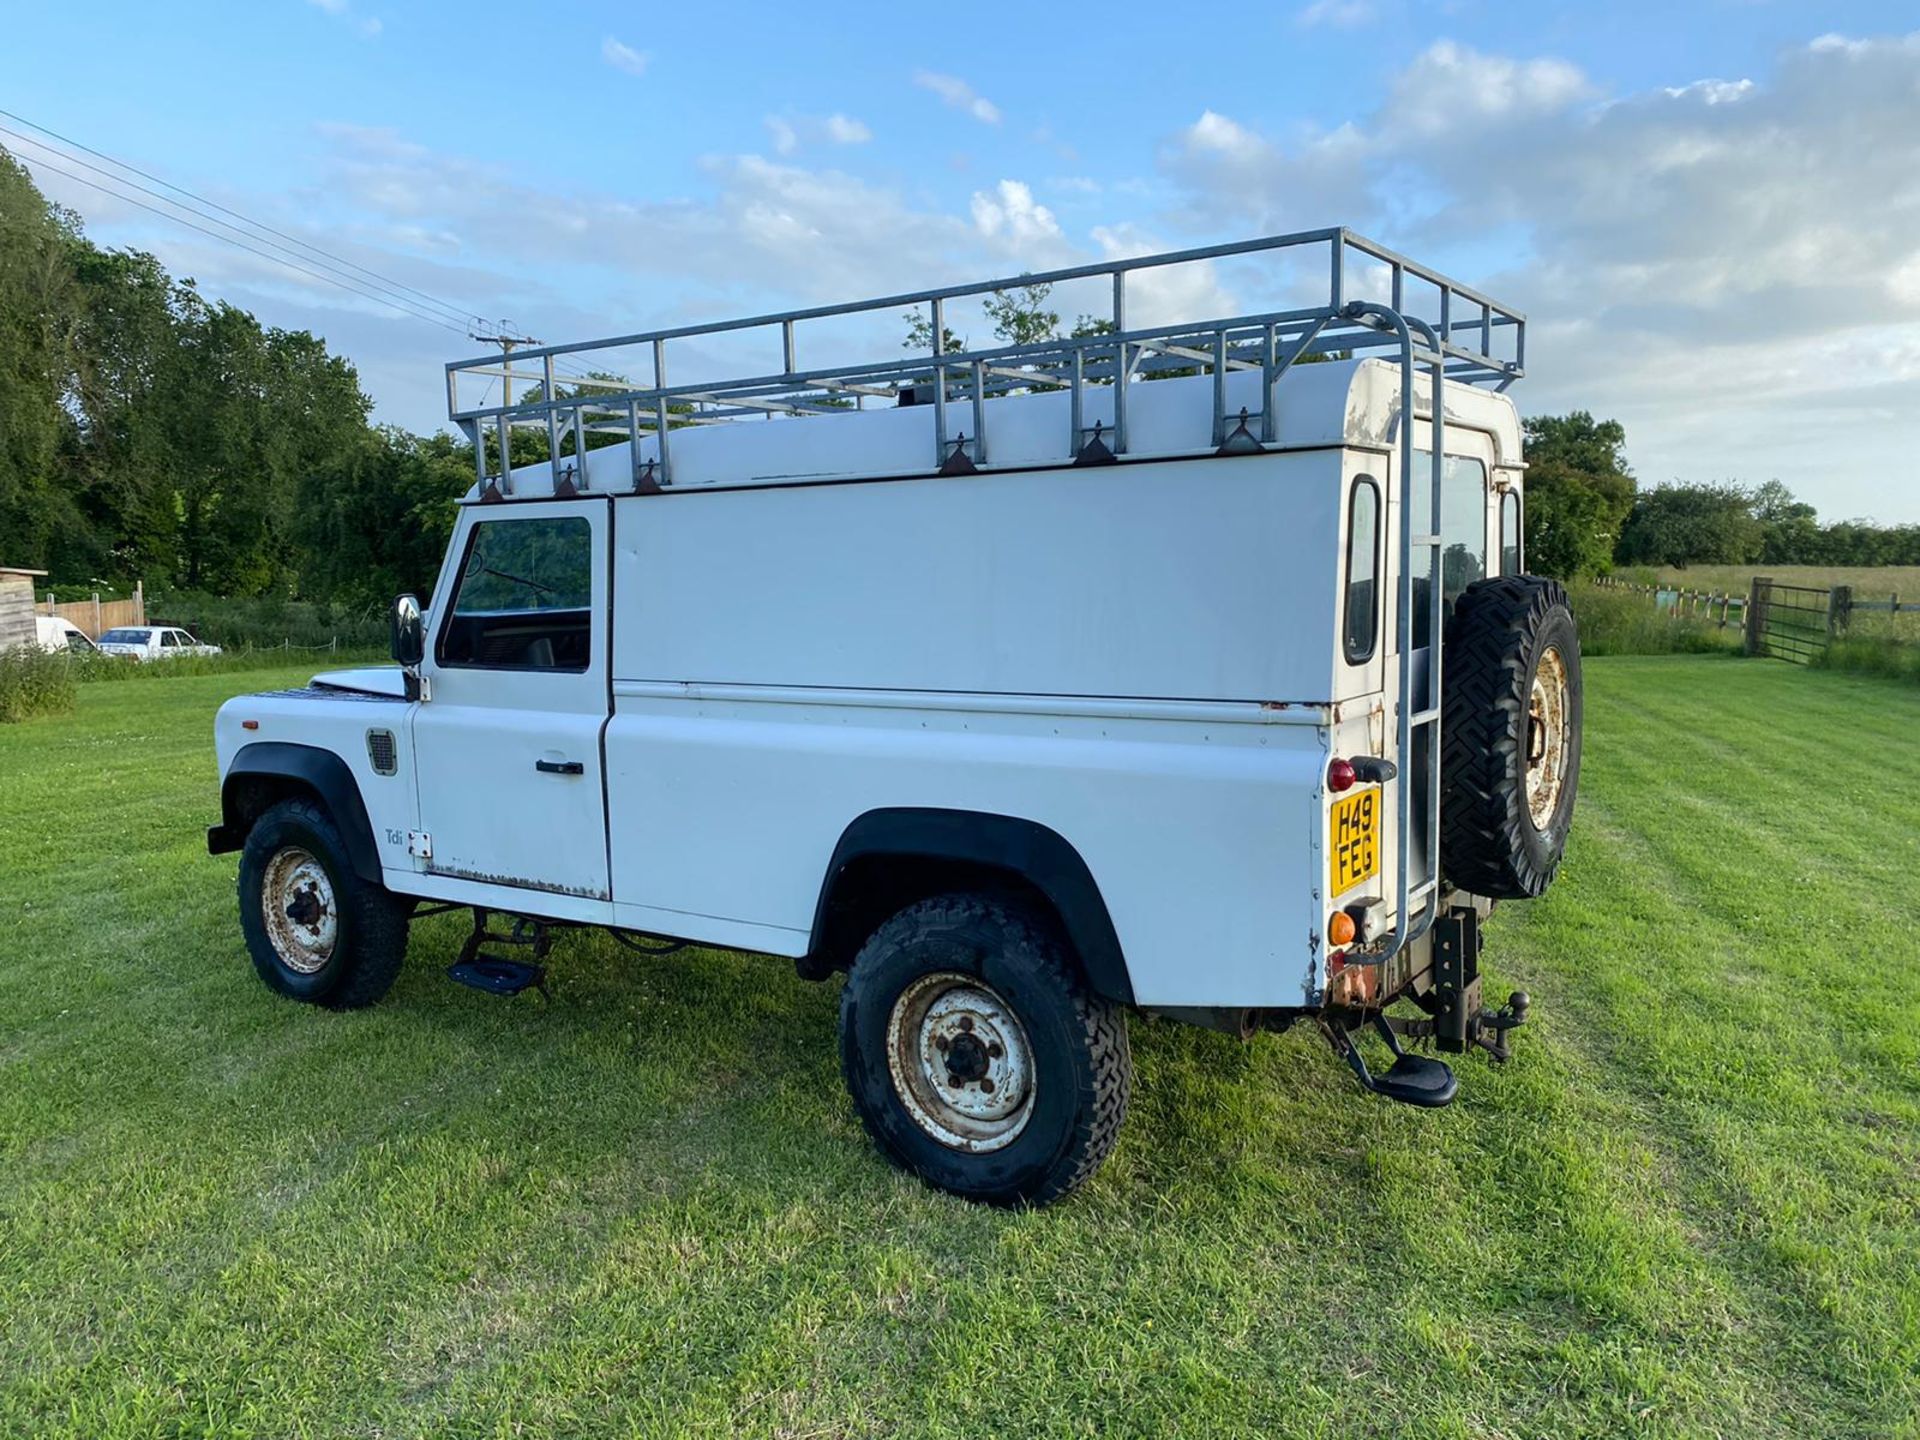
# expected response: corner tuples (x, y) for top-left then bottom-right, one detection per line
(465, 357), (1521, 503)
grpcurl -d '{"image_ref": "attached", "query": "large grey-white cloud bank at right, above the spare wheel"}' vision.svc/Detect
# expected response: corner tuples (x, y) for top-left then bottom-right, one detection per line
(1162, 35), (1920, 518)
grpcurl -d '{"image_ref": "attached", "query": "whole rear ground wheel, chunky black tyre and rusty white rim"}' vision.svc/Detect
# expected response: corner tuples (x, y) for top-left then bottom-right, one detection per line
(841, 895), (1133, 1206)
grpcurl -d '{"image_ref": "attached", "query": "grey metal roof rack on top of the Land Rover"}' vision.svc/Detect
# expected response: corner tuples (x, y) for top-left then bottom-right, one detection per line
(445, 228), (1526, 497)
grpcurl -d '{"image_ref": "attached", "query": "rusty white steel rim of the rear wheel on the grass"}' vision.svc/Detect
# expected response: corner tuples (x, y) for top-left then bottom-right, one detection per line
(887, 972), (1035, 1154)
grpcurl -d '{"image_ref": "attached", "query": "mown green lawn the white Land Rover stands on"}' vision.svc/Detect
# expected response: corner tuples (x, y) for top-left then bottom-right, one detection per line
(0, 657), (1920, 1440)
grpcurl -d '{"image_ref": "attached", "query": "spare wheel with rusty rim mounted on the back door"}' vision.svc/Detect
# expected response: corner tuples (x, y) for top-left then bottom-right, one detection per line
(1440, 576), (1580, 900)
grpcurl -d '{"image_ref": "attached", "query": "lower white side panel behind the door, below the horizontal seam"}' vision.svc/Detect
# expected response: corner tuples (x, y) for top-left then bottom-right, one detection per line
(607, 682), (1327, 1006)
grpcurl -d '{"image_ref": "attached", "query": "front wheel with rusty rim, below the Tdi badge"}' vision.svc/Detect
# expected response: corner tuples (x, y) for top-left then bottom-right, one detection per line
(240, 801), (411, 1010)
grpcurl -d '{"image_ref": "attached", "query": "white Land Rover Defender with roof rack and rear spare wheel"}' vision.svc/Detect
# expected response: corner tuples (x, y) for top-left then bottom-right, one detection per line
(209, 230), (1580, 1204)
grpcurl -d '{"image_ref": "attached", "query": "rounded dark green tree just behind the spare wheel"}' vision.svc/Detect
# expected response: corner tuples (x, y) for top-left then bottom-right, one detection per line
(1526, 411), (1634, 580)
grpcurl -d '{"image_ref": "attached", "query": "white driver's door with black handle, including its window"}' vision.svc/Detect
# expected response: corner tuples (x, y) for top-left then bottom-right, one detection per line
(413, 499), (611, 899)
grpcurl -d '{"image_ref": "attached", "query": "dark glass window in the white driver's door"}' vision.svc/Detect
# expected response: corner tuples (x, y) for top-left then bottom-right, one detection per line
(438, 515), (593, 670)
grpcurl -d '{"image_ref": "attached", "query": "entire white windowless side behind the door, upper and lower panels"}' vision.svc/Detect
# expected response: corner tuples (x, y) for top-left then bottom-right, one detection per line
(602, 447), (1365, 1006)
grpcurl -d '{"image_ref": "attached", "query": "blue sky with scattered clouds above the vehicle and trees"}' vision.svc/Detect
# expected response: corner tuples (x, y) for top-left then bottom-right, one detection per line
(0, 0), (1920, 520)
